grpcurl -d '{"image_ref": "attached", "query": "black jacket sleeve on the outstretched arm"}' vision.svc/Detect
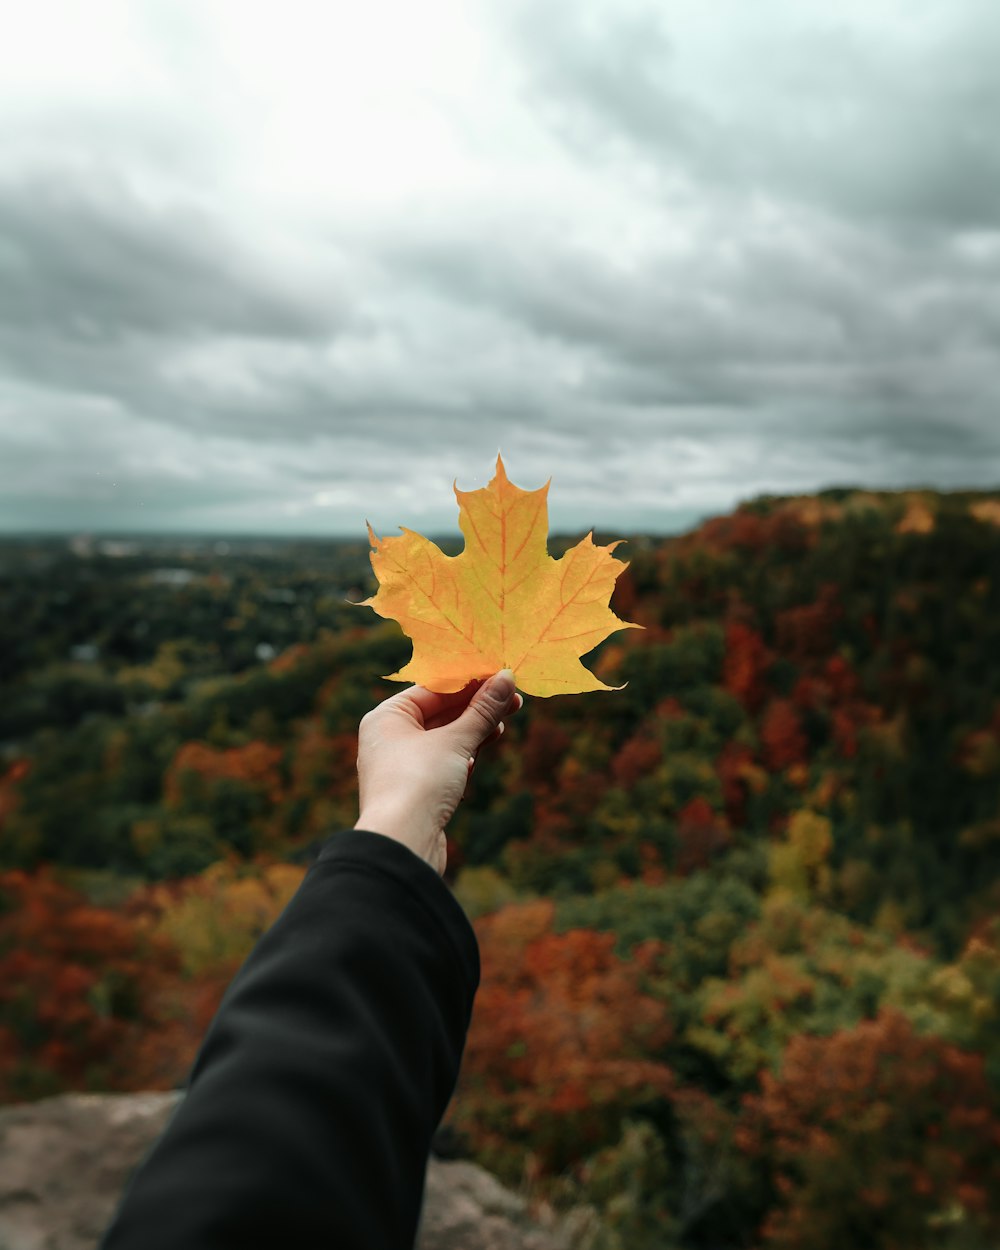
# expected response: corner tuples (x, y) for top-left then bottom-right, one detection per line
(101, 830), (479, 1250)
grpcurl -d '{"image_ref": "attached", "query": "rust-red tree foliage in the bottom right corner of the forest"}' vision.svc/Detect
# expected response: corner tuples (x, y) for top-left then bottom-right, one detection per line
(738, 1013), (1000, 1250)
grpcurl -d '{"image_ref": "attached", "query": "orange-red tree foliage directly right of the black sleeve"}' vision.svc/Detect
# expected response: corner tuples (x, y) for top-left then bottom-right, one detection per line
(456, 901), (673, 1171)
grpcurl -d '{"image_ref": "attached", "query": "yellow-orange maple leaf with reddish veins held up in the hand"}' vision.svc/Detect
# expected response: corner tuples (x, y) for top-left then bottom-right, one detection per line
(365, 456), (643, 696)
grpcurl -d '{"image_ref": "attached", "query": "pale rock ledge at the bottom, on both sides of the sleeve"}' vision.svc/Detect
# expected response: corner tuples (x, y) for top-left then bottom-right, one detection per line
(0, 1094), (584, 1250)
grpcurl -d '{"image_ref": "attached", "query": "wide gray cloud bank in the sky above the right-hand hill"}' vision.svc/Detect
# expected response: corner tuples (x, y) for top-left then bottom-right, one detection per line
(380, 192), (1000, 450)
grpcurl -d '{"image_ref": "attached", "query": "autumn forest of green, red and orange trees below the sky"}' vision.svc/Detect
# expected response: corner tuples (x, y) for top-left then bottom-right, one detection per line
(0, 489), (1000, 1250)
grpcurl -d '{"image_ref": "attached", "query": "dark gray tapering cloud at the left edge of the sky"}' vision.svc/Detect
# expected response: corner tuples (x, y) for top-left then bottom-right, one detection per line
(0, 174), (340, 343)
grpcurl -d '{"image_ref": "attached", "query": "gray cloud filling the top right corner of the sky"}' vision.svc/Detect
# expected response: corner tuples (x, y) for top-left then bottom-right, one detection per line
(511, 0), (1000, 228)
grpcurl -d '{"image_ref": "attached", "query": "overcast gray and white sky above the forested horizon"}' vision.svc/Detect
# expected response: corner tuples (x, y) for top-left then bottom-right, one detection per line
(0, 0), (1000, 536)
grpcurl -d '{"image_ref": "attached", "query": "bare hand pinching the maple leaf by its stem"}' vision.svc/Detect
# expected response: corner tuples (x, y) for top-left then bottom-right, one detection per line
(354, 669), (524, 873)
